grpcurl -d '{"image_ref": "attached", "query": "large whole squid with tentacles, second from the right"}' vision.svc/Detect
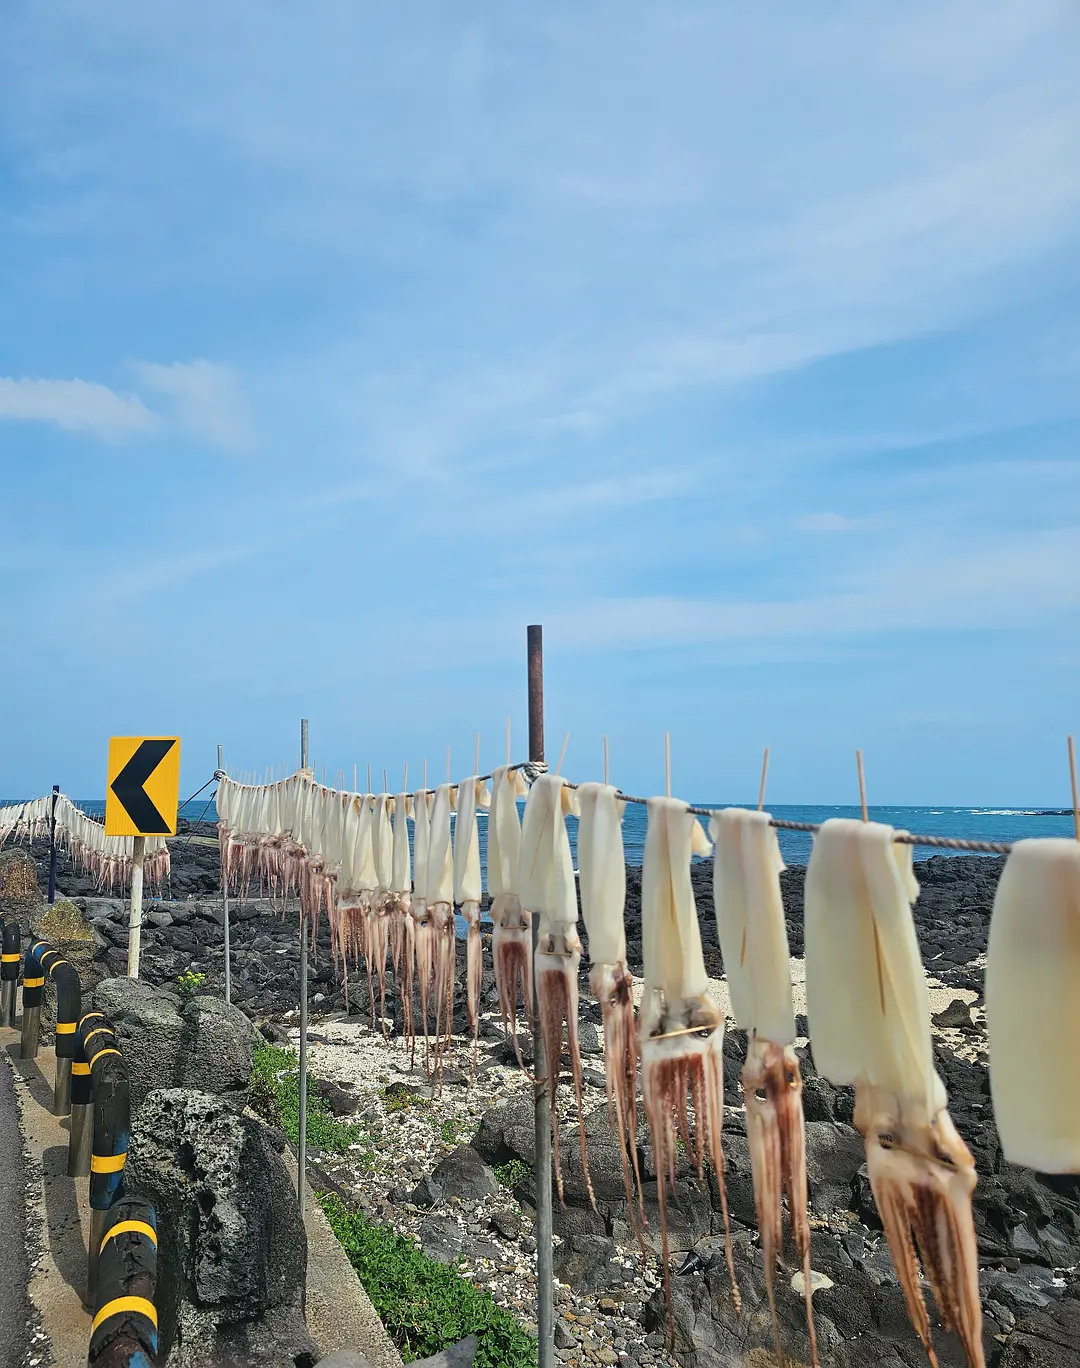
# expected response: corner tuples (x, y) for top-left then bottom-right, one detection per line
(806, 819), (984, 1368)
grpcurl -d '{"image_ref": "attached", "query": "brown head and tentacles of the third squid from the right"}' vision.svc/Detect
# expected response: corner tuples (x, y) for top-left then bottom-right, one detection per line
(742, 1036), (819, 1368)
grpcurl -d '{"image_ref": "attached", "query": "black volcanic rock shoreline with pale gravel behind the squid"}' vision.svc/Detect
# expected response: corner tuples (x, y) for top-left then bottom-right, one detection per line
(4, 841), (1080, 1368)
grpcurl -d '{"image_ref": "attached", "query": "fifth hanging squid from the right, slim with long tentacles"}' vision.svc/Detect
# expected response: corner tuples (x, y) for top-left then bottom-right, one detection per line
(578, 784), (645, 1222)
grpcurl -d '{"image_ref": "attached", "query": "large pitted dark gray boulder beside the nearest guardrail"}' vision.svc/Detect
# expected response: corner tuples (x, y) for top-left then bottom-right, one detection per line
(125, 1088), (318, 1368)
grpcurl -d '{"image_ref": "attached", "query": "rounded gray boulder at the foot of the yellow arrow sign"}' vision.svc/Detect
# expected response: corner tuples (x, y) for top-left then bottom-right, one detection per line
(94, 978), (257, 1109)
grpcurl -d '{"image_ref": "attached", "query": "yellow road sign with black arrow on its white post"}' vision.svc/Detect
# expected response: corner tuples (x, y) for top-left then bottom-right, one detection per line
(105, 736), (179, 978)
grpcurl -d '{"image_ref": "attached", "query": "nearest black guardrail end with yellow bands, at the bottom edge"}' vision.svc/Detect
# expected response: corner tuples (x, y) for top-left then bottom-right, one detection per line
(89, 1197), (157, 1368)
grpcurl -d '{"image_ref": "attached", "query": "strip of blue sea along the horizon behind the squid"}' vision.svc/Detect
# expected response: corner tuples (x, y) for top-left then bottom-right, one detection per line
(27, 798), (1073, 869)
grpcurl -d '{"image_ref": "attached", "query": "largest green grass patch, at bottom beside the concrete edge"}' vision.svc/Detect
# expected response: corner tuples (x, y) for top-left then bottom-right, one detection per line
(319, 1196), (537, 1368)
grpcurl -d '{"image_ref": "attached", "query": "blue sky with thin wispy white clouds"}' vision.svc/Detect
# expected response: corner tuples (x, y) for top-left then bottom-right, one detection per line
(0, 0), (1080, 806)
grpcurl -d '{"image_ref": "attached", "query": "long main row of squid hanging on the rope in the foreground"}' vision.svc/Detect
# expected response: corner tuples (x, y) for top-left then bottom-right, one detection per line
(218, 766), (1080, 1368)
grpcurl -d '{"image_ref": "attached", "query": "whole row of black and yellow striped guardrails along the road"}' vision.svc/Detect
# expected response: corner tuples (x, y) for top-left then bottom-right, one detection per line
(0, 919), (157, 1368)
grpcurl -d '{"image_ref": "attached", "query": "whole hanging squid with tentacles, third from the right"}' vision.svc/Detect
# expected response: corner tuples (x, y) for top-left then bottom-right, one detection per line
(709, 807), (817, 1368)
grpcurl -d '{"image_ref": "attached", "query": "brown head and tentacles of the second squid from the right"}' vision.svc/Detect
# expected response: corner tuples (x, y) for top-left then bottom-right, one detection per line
(856, 1085), (984, 1368)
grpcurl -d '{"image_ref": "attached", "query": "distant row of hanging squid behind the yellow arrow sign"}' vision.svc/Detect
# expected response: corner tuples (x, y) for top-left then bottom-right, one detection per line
(0, 793), (170, 893)
